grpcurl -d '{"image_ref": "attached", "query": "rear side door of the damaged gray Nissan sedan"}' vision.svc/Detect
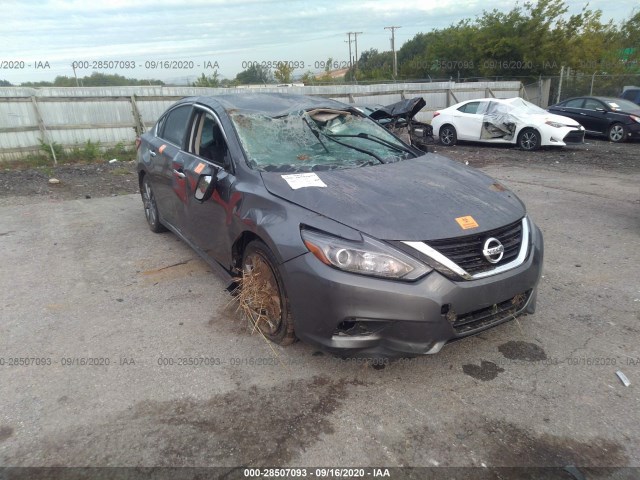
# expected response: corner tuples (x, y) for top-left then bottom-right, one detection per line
(150, 104), (193, 231)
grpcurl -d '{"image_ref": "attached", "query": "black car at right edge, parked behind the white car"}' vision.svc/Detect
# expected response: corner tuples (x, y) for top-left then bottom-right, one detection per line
(548, 97), (640, 142)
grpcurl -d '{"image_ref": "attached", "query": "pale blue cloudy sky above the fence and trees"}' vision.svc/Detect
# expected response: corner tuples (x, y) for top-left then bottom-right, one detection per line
(0, 0), (640, 85)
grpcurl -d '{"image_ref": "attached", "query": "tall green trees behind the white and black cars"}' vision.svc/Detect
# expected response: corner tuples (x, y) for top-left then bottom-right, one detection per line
(398, 0), (640, 80)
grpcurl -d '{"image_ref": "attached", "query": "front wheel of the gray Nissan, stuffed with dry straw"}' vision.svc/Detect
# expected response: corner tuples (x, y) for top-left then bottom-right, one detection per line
(240, 240), (296, 346)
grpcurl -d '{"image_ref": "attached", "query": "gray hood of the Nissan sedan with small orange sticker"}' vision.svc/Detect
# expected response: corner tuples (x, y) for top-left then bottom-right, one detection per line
(261, 154), (525, 241)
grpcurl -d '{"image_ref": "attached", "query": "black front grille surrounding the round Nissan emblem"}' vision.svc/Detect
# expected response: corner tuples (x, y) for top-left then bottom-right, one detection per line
(425, 220), (522, 275)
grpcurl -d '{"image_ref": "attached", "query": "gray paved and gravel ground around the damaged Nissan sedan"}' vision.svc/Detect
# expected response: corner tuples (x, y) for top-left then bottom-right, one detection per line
(0, 136), (640, 480)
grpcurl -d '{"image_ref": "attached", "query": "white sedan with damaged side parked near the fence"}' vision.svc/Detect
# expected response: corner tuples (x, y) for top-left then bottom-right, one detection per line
(431, 97), (584, 150)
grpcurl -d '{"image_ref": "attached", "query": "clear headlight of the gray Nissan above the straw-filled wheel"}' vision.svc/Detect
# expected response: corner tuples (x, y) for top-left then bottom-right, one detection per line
(300, 229), (433, 280)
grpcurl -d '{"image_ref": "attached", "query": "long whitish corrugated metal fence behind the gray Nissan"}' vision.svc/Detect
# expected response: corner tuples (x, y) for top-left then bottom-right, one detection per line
(0, 82), (525, 161)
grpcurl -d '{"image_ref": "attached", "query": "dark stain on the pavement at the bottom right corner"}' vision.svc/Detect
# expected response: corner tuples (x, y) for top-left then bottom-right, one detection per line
(393, 417), (631, 470)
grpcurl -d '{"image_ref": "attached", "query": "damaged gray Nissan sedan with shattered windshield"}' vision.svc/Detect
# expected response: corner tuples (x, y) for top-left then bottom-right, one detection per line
(138, 93), (543, 357)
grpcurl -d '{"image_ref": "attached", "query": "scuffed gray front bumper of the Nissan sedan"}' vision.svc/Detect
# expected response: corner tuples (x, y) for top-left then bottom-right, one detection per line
(281, 224), (544, 357)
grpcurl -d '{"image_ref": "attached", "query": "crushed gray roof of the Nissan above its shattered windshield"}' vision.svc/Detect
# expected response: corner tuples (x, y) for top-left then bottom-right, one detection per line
(182, 93), (352, 117)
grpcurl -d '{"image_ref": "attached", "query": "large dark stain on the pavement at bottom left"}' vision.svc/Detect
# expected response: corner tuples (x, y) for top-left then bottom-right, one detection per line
(5, 377), (363, 467)
